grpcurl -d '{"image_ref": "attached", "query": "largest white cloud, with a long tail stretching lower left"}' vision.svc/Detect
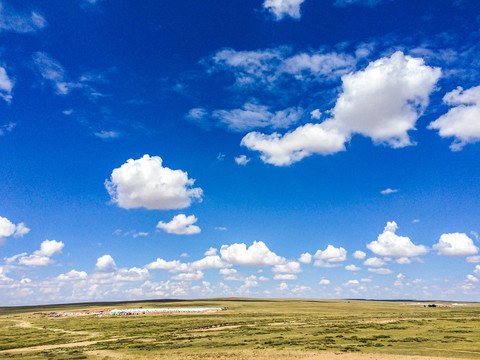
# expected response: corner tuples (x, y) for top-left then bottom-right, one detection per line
(241, 52), (441, 166)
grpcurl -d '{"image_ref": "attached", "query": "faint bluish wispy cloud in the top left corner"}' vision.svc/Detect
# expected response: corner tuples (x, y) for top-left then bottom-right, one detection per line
(0, 1), (47, 33)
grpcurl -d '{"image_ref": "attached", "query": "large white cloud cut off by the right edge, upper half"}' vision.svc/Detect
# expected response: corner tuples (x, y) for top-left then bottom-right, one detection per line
(429, 86), (480, 151)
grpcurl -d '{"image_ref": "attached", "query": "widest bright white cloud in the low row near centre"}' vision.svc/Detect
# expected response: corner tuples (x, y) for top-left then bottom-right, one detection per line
(220, 241), (285, 266)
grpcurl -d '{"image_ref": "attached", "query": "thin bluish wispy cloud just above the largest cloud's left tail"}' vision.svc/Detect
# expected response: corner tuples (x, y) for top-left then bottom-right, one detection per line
(212, 103), (303, 132)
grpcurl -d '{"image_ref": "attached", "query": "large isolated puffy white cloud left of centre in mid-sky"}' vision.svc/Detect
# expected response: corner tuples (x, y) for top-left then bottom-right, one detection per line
(105, 155), (203, 210)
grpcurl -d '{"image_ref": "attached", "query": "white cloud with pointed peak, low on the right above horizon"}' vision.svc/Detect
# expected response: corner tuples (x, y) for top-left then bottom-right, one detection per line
(367, 221), (428, 258)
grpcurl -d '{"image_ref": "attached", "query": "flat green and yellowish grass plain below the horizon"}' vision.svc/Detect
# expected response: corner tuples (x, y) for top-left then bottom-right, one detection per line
(0, 299), (480, 360)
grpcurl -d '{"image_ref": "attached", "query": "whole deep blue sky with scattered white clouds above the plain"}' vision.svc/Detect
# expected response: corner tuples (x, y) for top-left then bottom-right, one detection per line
(0, 0), (480, 305)
